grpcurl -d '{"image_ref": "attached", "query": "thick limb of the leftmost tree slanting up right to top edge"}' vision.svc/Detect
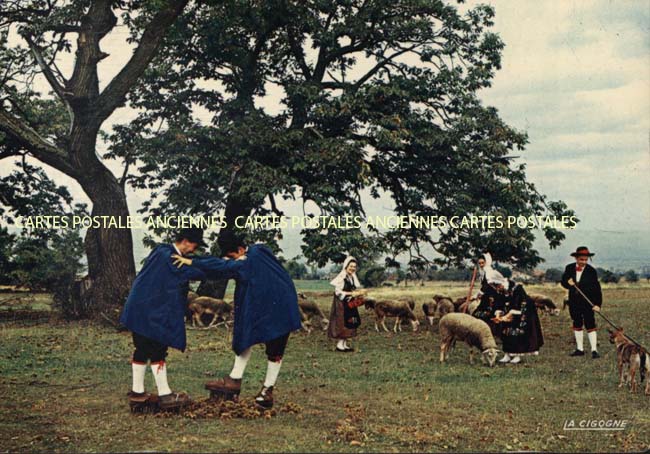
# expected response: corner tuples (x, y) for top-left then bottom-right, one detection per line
(96, 0), (189, 122)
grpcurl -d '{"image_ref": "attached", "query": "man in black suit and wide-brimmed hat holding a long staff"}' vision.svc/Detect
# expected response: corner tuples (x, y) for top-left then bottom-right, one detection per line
(561, 246), (603, 359)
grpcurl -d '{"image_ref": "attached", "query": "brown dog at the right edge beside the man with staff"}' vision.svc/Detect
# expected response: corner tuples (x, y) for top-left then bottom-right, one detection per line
(607, 328), (650, 395)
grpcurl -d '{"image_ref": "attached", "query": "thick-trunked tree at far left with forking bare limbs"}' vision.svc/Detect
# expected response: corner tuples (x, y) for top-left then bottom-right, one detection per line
(0, 0), (188, 313)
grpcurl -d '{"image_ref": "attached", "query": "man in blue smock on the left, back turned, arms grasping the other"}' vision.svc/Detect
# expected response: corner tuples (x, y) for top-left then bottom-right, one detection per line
(120, 228), (205, 409)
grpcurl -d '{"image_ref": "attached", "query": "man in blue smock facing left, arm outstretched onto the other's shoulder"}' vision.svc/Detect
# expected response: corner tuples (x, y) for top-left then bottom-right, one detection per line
(174, 232), (301, 408)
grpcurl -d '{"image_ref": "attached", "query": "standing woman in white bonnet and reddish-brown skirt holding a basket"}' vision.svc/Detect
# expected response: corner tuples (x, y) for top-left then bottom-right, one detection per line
(327, 256), (364, 352)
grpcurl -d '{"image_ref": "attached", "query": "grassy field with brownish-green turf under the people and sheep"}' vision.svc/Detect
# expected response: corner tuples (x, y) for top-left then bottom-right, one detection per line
(0, 282), (650, 452)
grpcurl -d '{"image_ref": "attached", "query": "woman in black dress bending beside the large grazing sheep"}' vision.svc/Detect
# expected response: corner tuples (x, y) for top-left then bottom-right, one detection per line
(497, 280), (544, 364)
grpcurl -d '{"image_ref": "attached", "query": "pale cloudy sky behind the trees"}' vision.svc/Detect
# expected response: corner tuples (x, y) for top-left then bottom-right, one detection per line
(0, 0), (650, 262)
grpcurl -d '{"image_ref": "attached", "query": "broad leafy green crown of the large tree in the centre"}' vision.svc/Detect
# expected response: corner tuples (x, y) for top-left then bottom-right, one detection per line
(112, 0), (573, 288)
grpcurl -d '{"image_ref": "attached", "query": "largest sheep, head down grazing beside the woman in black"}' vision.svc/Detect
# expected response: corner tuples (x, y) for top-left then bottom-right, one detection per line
(438, 313), (499, 367)
